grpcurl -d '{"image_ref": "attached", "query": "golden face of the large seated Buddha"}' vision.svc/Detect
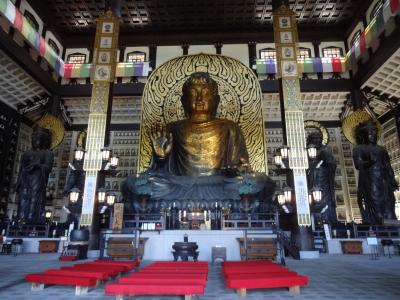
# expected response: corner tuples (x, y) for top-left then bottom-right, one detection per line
(188, 83), (214, 119)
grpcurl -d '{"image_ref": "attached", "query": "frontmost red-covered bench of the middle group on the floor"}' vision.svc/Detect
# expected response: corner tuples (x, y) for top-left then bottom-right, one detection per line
(105, 283), (204, 295)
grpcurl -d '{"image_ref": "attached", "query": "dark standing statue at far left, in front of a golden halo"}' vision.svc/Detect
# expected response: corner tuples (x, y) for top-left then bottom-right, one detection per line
(16, 127), (54, 224)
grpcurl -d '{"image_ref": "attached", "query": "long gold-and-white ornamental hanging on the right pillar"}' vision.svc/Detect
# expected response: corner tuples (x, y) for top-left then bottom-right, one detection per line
(273, 1), (311, 226)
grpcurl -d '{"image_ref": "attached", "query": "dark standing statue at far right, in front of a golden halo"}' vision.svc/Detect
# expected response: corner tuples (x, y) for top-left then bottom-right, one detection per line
(353, 120), (398, 224)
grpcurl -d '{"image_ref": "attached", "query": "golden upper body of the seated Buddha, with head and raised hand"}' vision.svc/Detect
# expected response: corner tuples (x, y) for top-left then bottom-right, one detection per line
(151, 72), (248, 176)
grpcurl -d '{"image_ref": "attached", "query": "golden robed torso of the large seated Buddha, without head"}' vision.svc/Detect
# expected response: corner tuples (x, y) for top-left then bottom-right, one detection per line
(165, 119), (248, 176)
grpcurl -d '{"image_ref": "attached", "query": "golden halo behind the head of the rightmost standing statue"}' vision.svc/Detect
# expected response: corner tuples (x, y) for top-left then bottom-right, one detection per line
(342, 109), (382, 145)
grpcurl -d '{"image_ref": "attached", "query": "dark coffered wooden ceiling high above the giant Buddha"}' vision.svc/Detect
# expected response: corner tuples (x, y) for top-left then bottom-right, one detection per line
(28, 0), (372, 44)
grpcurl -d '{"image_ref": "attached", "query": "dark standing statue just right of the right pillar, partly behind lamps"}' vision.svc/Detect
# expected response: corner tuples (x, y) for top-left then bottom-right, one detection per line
(307, 131), (337, 224)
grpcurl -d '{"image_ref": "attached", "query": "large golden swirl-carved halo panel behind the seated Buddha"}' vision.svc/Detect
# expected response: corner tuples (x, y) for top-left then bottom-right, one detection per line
(138, 54), (267, 173)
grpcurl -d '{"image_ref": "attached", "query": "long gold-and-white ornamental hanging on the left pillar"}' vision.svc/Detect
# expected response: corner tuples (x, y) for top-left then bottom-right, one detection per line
(80, 11), (119, 226)
